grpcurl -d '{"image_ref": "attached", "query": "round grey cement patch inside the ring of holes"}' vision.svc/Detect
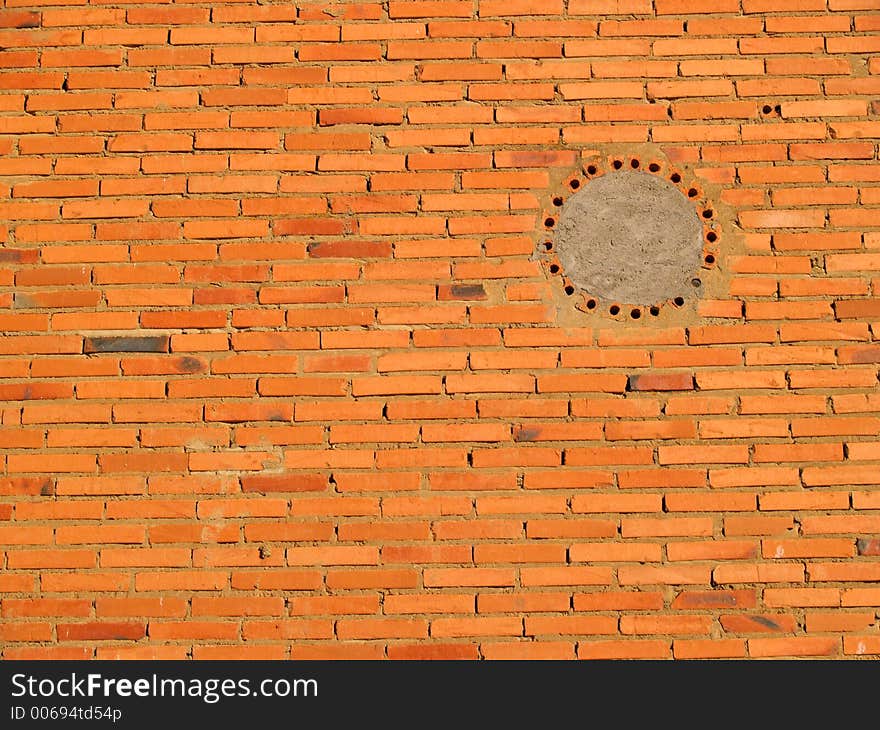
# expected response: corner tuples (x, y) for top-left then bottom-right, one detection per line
(554, 170), (703, 304)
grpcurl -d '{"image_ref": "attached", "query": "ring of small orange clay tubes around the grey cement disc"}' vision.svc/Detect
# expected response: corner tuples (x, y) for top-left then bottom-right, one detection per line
(544, 157), (721, 320)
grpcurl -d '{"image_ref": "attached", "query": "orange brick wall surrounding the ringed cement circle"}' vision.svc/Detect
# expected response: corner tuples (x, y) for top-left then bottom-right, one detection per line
(0, 0), (880, 659)
